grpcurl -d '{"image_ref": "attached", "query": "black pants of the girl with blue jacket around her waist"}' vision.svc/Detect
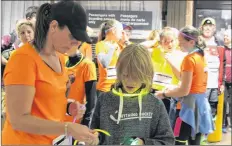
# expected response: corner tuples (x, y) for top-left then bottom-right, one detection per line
(175, 110), (201, 145)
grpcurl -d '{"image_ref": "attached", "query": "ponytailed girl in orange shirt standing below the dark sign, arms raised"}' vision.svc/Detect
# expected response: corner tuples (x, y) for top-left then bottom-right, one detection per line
(96, 20), (123, 96)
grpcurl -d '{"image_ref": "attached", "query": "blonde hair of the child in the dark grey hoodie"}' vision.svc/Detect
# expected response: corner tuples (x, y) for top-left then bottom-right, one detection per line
(115, 44), (154, 91)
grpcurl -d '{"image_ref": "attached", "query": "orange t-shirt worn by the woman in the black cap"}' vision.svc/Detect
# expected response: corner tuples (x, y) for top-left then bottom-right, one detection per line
(2, 44), (68, 145)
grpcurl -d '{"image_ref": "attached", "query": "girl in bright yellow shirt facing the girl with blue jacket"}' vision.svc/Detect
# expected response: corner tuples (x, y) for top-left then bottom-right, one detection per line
(152, 27), (184, 112)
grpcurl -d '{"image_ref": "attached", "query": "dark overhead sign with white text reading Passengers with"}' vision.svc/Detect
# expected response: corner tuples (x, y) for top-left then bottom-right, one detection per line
(87, 10), (152, 30)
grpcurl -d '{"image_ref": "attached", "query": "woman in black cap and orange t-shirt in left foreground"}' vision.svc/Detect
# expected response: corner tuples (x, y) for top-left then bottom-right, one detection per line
(2, 1), (98, 145)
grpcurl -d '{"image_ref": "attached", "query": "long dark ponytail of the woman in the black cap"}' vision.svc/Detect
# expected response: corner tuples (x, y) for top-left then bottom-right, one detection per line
(33, 3), (52, 52)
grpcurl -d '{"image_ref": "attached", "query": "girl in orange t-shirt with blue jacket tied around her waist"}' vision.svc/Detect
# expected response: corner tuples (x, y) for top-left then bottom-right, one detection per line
(156, 26), (214, 145)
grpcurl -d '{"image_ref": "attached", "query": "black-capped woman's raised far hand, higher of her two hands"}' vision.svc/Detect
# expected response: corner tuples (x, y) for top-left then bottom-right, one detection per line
(69, 101), (86, 120)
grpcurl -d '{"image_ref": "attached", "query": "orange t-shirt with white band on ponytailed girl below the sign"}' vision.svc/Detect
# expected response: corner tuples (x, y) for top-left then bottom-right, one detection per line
(96, 41), (121, 92)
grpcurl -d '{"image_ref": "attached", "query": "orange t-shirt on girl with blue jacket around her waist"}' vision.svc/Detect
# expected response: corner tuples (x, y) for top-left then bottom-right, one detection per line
(181, 52), (208, 94)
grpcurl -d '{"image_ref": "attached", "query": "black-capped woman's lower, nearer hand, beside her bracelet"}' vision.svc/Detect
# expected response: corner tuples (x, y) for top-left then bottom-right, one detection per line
(68, 123), (99, 145)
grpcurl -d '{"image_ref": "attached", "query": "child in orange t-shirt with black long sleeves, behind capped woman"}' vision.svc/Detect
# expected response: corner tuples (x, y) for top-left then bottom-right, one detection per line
(65, 47), (97, 126)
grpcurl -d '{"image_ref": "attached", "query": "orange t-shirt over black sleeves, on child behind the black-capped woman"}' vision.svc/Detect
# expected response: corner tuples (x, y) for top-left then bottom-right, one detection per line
(65, 58), (97, 122)
